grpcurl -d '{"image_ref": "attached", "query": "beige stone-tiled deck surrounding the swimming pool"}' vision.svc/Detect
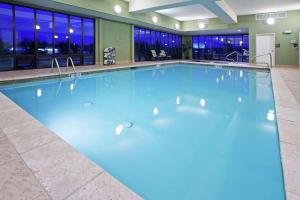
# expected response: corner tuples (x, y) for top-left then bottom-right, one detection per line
(0, 61), (300, 200)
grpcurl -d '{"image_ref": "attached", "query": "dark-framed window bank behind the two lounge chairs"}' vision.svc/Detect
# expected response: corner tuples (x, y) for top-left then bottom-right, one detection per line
(134, 27), (182, 61)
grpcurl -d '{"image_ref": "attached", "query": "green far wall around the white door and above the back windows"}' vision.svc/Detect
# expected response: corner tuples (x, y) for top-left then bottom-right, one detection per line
(182, 11), (300, 66)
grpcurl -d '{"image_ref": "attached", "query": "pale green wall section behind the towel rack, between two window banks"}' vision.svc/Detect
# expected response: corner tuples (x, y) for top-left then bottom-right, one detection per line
(96, 19), (133, 64)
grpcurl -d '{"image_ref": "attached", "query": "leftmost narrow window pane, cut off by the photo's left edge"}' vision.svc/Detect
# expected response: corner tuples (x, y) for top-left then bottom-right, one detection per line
(0, 3), (13, 71)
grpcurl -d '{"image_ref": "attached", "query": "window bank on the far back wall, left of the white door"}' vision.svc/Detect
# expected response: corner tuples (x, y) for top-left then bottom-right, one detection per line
(193, 34), (249, 62)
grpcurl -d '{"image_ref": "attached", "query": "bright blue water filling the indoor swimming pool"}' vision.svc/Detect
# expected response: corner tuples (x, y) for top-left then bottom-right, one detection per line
(1, 64), (285, 200)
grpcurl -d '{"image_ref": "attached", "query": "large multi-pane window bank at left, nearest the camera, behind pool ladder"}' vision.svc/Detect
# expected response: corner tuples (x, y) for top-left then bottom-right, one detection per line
(0, 3), (95, 71)
